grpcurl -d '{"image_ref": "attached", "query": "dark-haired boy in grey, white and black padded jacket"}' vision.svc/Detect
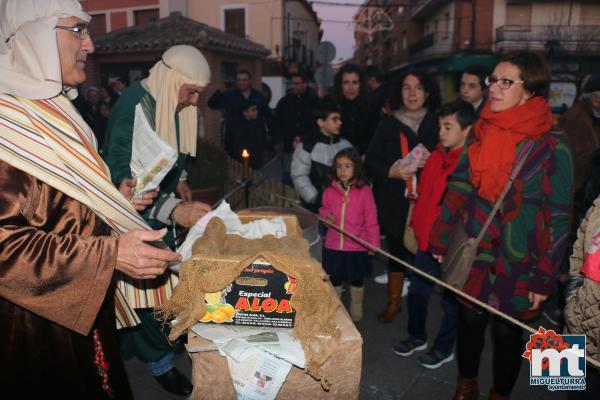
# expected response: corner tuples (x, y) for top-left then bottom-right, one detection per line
(291, 99), (352, 212)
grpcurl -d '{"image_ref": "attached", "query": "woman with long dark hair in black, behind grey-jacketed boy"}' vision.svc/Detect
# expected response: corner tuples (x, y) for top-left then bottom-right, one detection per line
(332, 64), (375, 154)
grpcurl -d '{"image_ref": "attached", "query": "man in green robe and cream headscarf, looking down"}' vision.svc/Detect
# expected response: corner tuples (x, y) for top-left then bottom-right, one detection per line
(103, 45), (211, 396)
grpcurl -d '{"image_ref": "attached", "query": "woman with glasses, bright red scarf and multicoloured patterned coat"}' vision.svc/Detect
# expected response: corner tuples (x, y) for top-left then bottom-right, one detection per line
(429, 53), (573, 400)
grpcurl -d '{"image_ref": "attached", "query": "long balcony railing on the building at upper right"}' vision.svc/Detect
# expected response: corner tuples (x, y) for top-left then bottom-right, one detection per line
(496, 25), (600, 53)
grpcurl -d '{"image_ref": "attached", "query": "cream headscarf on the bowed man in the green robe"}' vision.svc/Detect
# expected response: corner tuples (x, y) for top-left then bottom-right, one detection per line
(147, 45), (210, 157)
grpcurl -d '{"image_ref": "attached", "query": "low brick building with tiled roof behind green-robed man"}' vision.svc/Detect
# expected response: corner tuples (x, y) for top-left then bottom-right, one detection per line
(88, 13), (268, 139)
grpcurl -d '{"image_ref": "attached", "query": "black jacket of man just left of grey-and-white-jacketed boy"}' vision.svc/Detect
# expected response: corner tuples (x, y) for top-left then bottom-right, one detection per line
(274, 89), (318, 153)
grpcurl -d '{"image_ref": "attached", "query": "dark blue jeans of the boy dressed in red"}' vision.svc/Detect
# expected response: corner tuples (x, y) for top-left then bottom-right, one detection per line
(407, 251), (459, 354)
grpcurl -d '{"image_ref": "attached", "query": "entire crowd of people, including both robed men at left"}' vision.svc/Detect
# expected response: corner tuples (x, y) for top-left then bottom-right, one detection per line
(0, 0), (600, 400)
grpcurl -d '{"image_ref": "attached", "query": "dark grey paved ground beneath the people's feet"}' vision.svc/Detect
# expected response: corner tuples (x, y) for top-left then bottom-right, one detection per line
(126, 239), (566, 400)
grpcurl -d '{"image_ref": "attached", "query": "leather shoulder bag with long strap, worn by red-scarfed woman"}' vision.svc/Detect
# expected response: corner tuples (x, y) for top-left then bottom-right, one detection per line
(441, 140), (533, 289)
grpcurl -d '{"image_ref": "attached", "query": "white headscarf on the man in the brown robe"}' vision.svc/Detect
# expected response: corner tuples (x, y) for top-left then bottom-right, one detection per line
(0, 0), (91, 100)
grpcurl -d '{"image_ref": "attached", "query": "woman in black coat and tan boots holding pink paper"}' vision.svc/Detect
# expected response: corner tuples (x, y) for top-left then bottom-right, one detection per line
(366, 71), (440, 322)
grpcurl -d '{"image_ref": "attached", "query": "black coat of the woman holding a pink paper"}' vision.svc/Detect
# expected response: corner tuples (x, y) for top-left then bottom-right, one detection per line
(366, 111), (439, 237)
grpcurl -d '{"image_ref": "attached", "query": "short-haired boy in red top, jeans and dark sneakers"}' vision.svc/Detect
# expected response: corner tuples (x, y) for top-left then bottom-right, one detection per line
(394, 100), (477, 369)
